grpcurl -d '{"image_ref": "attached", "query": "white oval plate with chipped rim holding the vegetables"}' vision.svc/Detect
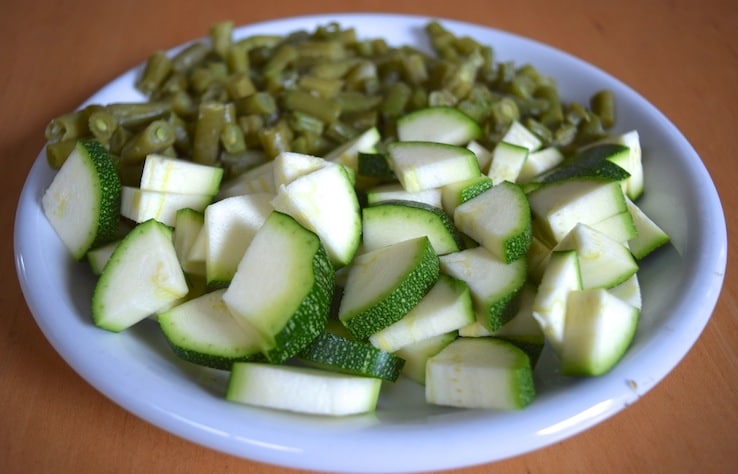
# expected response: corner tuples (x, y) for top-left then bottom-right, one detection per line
(15, 14), (727, 472)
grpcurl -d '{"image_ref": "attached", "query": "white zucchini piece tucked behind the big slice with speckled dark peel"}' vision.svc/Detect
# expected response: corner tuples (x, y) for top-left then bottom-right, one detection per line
(203, 193), (274, 284)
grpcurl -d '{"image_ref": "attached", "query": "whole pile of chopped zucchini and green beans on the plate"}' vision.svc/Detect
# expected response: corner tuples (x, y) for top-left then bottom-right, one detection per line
(42, 21), (669, 415)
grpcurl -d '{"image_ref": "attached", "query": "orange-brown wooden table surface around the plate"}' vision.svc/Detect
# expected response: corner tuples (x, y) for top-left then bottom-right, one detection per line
(0, 0), (738, 474)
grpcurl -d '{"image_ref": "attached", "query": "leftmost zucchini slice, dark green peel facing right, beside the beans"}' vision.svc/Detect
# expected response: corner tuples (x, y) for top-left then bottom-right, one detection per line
(41, 141), (121, 260)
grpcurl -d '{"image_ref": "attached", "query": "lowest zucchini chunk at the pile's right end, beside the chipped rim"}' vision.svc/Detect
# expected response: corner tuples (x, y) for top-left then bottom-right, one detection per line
(560, 288), (640, 376)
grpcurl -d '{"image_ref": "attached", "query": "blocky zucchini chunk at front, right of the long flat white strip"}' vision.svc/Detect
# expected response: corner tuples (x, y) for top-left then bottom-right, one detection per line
(425, 337), (535, 410)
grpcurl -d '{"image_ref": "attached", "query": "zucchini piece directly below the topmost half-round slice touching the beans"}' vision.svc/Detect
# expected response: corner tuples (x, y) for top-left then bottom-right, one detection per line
(387, 141), (481, 192)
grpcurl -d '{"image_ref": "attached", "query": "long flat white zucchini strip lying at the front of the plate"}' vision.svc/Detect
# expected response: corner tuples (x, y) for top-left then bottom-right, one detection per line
(226, 362), (382, 416)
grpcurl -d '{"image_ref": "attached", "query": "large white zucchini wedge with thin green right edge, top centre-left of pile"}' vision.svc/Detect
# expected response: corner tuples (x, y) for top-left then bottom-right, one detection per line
(272, 161), (361, 267)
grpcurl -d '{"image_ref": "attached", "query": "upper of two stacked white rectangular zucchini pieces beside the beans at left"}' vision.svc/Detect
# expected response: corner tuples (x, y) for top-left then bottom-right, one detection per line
(139, 154), (223, 196)
